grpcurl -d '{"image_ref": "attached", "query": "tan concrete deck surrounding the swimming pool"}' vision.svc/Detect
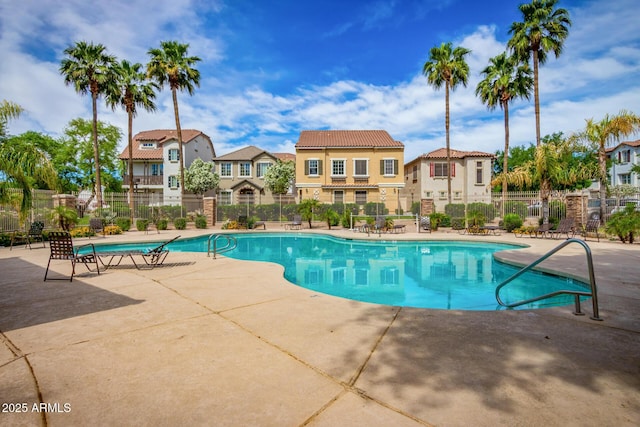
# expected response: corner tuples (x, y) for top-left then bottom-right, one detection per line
(0, 224), (640, 426)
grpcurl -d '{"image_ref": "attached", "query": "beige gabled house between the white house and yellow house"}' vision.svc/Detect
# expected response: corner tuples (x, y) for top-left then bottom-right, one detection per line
(213, 145), (293, 205)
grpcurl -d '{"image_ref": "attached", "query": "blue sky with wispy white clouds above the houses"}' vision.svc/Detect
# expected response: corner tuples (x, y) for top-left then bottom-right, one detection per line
(0, 0), (640, 161)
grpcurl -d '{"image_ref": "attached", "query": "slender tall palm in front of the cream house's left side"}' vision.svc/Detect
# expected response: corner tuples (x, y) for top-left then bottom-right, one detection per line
(422, 43), (471, 204)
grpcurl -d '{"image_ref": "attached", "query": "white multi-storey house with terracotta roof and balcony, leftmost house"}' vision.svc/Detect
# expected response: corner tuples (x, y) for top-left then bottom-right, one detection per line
(120, 129), (216, 205)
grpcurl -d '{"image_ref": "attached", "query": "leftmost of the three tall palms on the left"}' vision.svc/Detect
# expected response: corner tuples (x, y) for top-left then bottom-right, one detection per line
(60, 41), (117, 207)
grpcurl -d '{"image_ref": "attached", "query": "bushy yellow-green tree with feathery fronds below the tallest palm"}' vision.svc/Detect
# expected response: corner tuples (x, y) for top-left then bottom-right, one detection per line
(491, 133), (595, 224)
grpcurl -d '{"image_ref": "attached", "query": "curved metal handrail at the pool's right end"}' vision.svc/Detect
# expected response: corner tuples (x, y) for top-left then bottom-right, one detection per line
(496, 239), (603, 320)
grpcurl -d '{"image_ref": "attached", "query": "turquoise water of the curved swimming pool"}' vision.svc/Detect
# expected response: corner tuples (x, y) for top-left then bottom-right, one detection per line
(91, 233), (588, 310)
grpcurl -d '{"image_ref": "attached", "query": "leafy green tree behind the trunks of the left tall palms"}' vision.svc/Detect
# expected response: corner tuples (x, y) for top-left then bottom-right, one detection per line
(58, 118), (122, 195)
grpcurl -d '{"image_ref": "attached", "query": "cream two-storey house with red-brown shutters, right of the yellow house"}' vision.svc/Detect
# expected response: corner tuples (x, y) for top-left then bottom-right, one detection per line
(402, 148), (495, 213)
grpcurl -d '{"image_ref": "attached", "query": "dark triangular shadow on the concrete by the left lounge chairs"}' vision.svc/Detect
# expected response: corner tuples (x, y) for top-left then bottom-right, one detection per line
(0, 258), (143, 332)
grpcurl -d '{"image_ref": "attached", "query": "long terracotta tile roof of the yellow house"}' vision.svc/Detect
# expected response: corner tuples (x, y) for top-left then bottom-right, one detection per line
(296, 130), (404, 149)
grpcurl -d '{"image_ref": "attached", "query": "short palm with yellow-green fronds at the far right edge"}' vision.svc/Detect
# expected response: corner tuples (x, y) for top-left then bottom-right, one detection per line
(573, 110), (640, 219)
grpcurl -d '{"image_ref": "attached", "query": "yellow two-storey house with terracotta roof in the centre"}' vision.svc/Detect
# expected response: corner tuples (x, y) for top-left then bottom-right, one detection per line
(295, 130), (404, 213)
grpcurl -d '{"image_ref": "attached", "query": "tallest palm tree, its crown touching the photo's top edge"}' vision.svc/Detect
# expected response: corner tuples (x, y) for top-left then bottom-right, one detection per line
(507, 0), (571, 146)
